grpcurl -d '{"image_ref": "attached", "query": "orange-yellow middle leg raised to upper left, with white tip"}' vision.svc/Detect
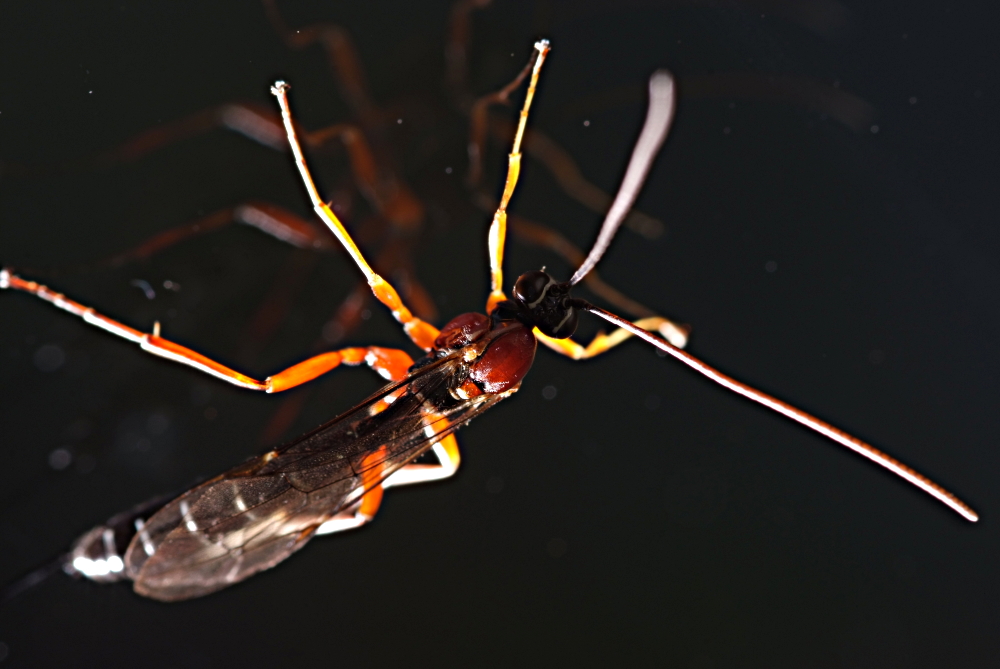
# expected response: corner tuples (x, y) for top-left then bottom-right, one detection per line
(271, 82), (438, 351)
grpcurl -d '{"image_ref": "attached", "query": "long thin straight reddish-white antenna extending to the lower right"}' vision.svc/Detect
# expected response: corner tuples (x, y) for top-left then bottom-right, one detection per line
(579, 300), (979, 522)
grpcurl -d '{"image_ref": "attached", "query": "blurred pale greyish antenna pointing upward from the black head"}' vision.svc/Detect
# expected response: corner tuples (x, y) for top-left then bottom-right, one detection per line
(569, 70), (675, 285)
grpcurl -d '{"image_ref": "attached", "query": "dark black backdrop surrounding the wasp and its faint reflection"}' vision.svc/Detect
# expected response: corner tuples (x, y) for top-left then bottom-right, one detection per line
(0, 0), (1000, 668)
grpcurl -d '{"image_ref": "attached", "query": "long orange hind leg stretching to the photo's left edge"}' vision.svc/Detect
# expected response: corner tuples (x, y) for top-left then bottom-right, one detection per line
(0, 269), (413, 393)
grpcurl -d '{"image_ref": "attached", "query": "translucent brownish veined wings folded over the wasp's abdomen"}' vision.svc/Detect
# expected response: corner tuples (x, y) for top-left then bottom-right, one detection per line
(125, 355), (508, 601)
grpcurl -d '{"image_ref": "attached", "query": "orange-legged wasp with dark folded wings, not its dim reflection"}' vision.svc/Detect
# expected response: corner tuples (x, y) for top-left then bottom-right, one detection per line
(0, 40), (978, 601)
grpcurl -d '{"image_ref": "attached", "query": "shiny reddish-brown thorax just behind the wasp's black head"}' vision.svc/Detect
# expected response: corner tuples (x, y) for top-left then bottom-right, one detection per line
(434, 313), (537, 394)
